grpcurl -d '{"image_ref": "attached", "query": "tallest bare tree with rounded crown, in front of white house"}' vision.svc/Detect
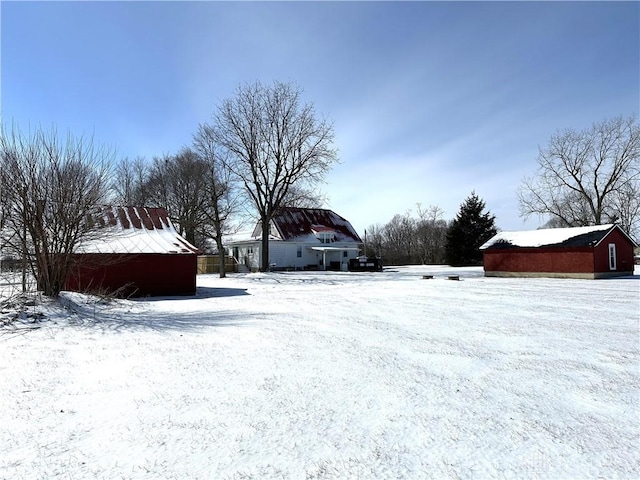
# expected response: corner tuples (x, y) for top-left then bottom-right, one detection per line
(212, 82), (337, 271)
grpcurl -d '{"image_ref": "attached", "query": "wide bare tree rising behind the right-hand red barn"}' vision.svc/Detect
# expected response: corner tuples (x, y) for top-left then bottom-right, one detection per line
(518, 117), (640, 238)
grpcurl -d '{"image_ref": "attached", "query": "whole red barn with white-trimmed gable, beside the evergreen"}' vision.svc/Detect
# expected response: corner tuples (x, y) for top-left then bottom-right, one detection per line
(480, 225), (636, 278)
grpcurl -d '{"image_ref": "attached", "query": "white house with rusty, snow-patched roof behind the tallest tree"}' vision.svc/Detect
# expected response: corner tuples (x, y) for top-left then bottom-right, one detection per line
(225, 208), (362, 271)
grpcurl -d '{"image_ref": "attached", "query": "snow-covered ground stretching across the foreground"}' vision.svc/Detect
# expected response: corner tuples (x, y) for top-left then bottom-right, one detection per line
(0, 267), (640, 479)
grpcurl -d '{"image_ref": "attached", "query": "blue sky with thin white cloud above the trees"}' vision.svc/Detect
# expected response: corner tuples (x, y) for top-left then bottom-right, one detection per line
(0, 1), (640, 233)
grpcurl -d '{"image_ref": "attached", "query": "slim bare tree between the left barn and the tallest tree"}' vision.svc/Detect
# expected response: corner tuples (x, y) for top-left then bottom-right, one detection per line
(193, 125), (239, 278)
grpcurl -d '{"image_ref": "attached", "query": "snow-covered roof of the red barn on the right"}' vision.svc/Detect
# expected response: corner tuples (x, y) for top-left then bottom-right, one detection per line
(480, 224), (635, 250)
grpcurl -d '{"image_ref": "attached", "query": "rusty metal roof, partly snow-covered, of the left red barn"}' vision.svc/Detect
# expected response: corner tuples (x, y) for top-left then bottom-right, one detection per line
(76, 206), (199, 254)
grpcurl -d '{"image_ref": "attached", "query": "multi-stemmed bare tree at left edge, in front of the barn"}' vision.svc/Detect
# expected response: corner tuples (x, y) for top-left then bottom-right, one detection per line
(0, 124), (113, 297)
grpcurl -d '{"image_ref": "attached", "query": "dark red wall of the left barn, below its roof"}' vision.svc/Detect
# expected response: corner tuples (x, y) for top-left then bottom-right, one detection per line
(66, 254), (197, 297)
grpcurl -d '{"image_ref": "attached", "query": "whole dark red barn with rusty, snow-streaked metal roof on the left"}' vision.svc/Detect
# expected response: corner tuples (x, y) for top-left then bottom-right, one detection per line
(65, 207), (198, 296)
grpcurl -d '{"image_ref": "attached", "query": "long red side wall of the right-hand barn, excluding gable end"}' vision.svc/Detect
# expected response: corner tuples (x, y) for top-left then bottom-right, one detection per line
(484, 247), (594, 273)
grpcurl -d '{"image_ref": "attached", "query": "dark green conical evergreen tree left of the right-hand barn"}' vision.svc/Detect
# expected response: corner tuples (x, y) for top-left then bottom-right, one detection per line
(445, 192), (497, 266)
